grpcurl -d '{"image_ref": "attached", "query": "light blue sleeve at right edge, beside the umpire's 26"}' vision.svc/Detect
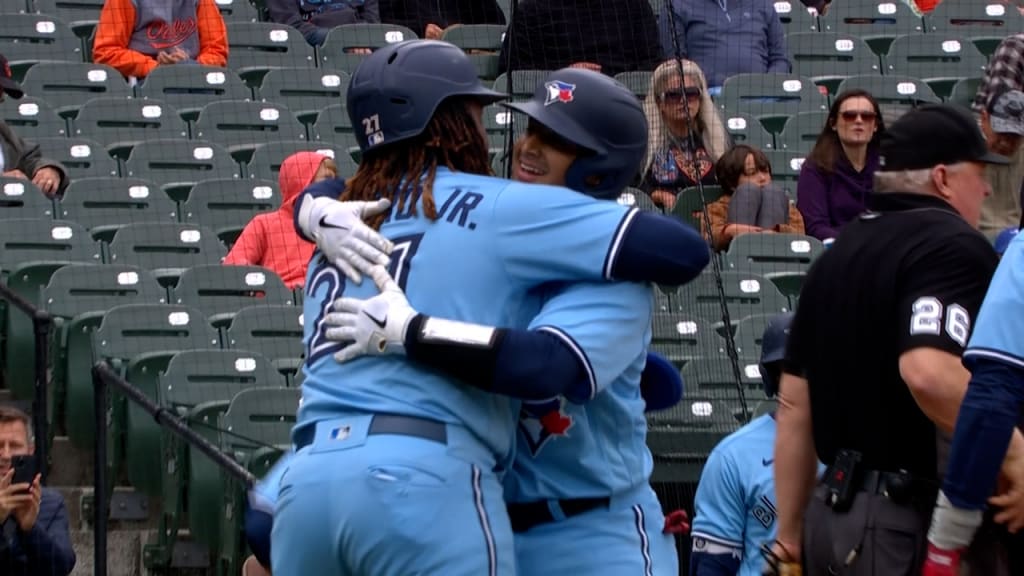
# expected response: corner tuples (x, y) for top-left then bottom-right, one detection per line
(964, 235), (1024, 368)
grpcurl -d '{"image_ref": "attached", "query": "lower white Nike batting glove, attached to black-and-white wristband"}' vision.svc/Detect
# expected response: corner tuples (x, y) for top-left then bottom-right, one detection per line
(324, 266), (418, 363)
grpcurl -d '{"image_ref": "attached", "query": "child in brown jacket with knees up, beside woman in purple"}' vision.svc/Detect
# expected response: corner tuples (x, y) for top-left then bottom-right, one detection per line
(695, 145), (804, 250)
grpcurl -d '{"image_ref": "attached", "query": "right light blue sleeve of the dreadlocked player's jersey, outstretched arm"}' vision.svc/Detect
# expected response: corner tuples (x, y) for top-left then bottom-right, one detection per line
(493, 182), (636, 284)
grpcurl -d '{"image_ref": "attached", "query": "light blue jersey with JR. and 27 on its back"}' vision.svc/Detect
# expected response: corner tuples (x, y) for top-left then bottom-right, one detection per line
(297, 169), (635, 463)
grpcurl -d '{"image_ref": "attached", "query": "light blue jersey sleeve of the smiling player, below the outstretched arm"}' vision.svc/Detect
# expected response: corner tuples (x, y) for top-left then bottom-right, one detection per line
(529, 282), (652, 403)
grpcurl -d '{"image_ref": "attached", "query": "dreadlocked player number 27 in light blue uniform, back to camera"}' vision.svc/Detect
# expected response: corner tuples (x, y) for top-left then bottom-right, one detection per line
(271, 40), (709, 576)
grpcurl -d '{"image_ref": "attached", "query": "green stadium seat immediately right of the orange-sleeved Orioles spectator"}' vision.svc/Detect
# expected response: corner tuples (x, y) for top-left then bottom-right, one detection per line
(226, 22), (316, 79)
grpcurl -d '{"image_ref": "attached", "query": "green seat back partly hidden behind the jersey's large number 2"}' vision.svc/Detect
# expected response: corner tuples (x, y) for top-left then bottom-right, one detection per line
(224, 304), (305, 374)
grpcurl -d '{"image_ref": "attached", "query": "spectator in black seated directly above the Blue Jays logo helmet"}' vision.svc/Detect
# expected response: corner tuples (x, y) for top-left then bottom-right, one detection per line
(501, 0), (665, 77)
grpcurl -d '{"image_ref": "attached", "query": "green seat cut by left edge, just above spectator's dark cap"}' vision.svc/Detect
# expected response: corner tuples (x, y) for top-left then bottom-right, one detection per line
(0, 14), (82, 73)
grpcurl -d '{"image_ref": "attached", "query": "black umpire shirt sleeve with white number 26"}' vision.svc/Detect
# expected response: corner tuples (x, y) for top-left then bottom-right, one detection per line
(896, 235), (997, 356)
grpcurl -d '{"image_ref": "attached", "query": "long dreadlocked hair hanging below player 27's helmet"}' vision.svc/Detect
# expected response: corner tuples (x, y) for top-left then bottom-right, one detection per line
(341, 98), (492, 230)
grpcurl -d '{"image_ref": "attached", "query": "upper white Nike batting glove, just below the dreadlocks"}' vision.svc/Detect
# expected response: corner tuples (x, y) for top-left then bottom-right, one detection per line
(298, 192), (394, 284)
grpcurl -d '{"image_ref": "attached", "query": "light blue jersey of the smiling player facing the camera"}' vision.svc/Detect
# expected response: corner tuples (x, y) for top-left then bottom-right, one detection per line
(505, 283), (653, 502)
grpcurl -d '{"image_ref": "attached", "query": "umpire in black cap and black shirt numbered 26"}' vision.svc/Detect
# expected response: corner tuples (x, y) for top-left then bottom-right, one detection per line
(773, 105), (1021, 576)
